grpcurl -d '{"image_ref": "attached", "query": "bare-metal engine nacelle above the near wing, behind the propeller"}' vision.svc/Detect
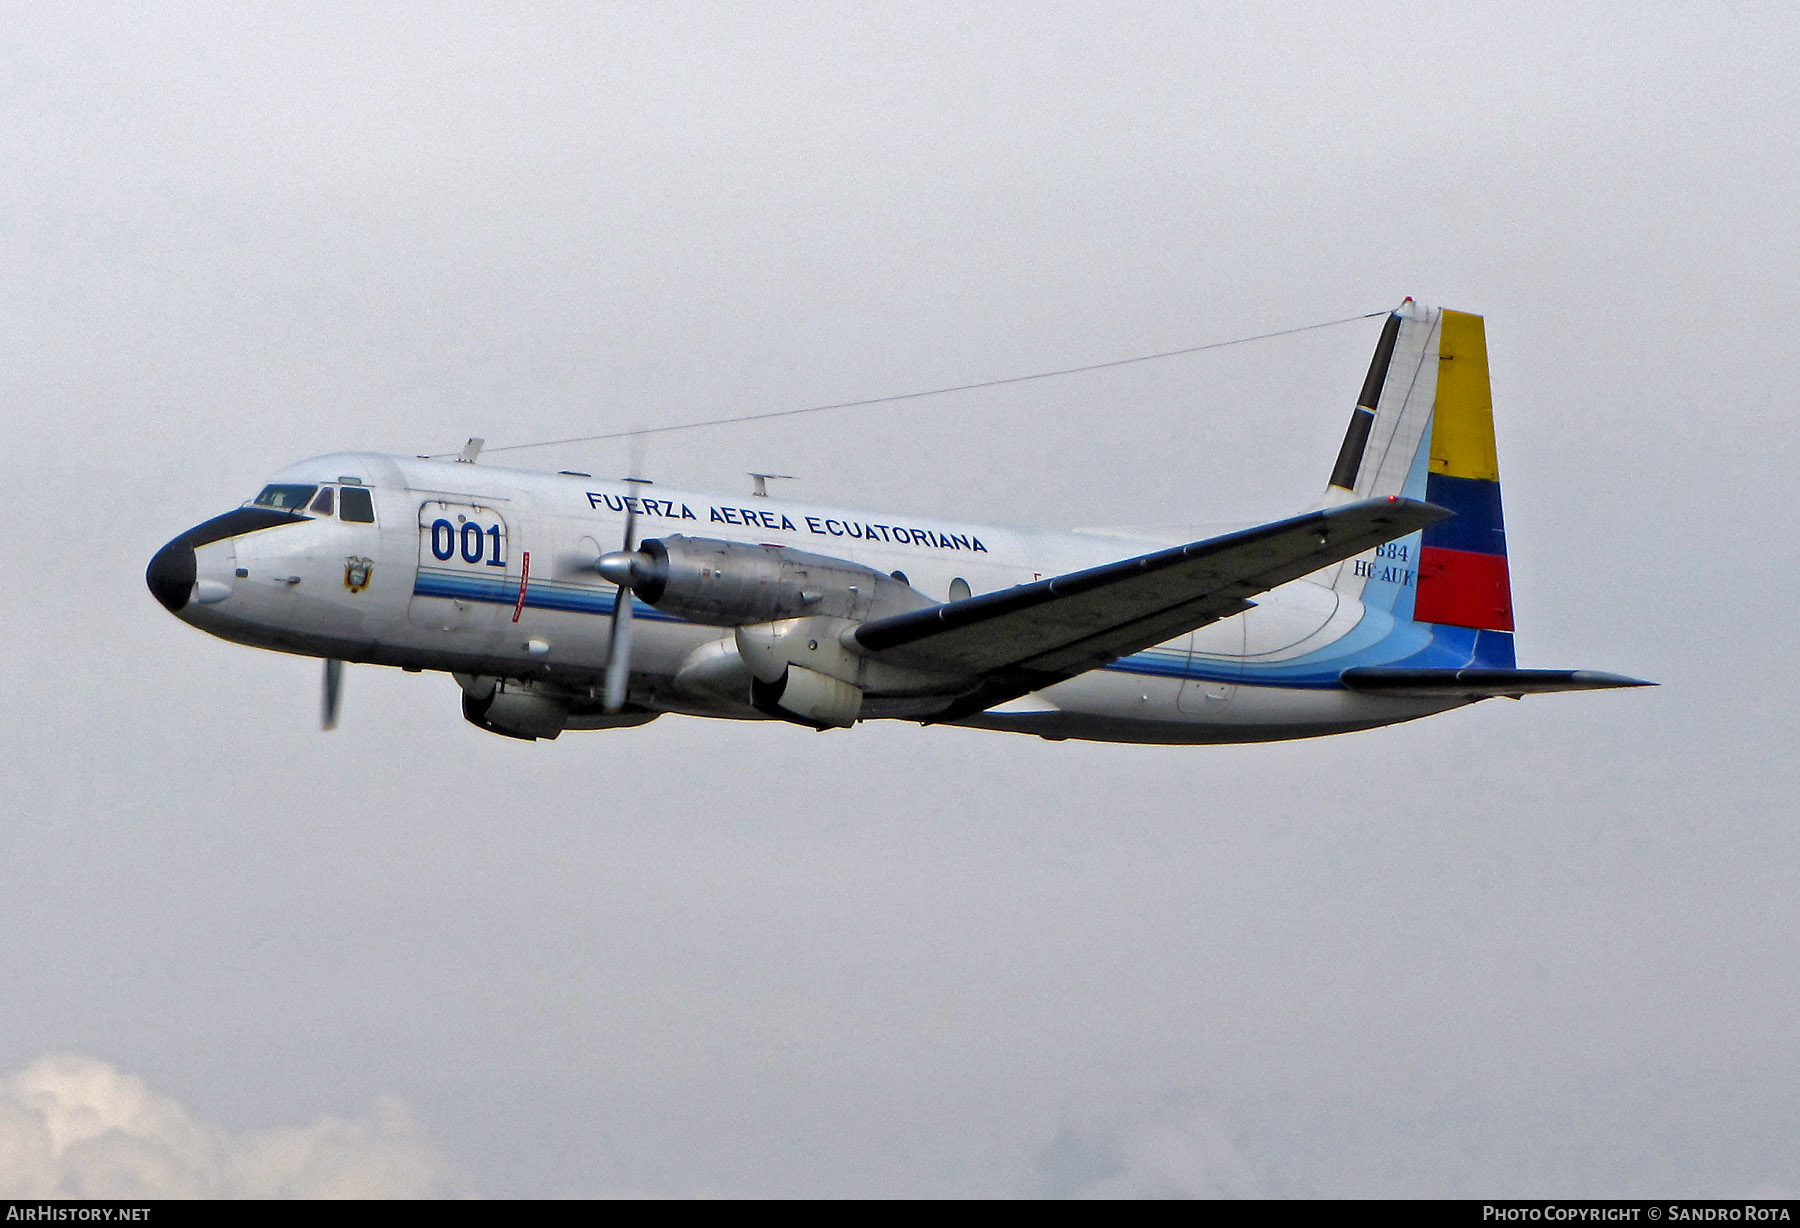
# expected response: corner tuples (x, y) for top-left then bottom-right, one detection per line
(632, 533), (936, 627)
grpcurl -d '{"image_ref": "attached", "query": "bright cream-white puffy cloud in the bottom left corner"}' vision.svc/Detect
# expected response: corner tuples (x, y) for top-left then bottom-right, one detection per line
(0, 1053), (457, 1197)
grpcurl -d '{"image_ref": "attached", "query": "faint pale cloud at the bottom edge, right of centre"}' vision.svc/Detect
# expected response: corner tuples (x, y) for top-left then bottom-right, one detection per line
(1037, 1100), (1274, 1199)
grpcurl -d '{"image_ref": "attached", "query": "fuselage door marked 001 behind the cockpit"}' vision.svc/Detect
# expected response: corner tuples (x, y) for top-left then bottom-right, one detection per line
(407, 501), (518, 632)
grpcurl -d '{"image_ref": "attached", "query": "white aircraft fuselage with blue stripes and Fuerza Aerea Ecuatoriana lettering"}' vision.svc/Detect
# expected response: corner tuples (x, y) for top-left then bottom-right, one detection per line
(158, 452), (1463, 744)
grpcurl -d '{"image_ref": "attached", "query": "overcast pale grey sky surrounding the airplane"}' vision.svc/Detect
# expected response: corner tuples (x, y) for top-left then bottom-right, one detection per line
(0, 2), (1800, 1197)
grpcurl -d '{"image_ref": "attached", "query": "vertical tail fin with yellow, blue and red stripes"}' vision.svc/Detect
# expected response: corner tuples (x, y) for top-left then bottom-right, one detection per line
(1325, 299), (1514, 670)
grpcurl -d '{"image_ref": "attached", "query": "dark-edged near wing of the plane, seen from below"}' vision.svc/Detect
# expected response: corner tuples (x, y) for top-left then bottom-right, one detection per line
(855, 499), (1451, 695)
